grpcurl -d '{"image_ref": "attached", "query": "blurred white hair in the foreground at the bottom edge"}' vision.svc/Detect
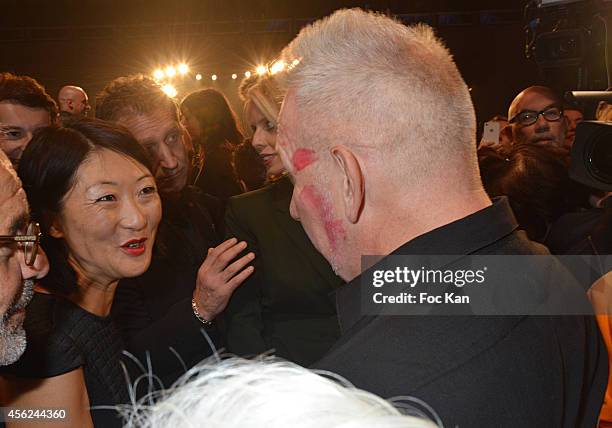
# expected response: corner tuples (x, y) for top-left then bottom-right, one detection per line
(124, 358), (437, 428)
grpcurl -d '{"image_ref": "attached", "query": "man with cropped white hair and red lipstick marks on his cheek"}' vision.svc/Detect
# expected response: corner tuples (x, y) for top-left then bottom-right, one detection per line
(277, 9), (607, 427)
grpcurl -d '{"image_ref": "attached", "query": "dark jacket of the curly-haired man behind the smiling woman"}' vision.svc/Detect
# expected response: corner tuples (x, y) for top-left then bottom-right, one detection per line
(112, 186), (223, 387)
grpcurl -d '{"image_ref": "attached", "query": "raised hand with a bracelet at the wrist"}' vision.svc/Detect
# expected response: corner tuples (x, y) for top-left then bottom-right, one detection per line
(193, 238), (255, 321)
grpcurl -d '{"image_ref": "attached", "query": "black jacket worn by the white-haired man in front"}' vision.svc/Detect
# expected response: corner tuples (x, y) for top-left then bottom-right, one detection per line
(315, 198), (608, 428)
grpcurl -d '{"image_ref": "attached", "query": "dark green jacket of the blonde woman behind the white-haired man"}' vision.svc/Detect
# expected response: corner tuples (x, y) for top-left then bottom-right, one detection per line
(225, 177), (342, 365)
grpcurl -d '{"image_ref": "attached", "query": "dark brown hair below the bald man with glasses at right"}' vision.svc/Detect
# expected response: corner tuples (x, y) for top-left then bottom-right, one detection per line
(478, 143), (589, 242)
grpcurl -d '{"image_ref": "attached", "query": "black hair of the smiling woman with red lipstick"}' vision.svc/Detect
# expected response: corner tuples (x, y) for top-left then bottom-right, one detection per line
(18, 119), (152, 295)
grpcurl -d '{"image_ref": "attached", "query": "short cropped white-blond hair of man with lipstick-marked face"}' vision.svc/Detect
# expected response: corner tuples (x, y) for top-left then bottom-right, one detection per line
(279, 9), (480, 188)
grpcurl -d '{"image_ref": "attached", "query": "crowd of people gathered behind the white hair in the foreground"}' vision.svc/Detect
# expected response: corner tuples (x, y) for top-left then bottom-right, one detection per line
(0, 9), (612, 427)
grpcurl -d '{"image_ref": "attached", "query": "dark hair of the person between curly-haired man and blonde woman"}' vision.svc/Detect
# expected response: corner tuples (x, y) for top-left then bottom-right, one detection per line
(181, 88), (244, 147)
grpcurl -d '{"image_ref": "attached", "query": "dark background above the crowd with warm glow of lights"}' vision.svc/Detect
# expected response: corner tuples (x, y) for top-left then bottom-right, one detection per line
(0, 0), (608, 128)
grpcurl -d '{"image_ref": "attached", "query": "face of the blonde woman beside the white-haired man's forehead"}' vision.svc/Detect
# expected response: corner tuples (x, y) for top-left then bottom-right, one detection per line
(246, 102), (285, 177)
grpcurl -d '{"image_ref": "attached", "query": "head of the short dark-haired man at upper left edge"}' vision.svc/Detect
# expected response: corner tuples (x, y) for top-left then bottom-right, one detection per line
(0, 73), (57, 168)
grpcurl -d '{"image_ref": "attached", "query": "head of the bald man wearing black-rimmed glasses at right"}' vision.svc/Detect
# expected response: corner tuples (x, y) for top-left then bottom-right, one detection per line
(508, 86), (567, 147)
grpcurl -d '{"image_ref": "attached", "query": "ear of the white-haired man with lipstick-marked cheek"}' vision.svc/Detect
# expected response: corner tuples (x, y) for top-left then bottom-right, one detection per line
(331, 146), (365, 223)
